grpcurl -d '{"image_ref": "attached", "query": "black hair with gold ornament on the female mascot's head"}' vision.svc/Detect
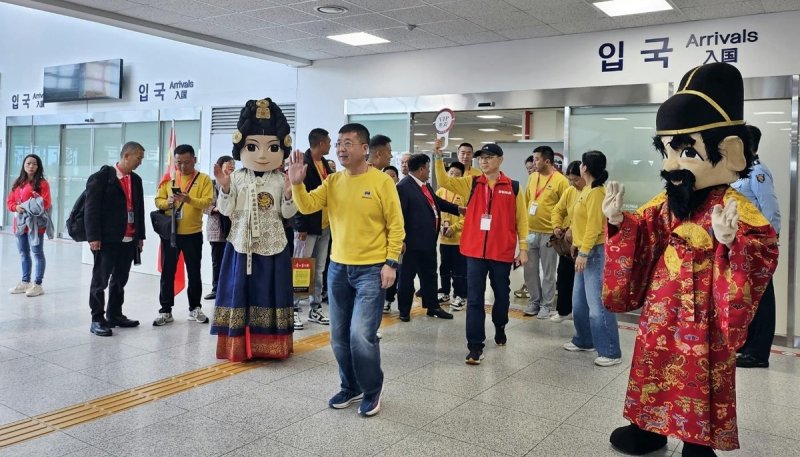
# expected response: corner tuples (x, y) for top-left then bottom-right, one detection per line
(233, 98), (292, 160)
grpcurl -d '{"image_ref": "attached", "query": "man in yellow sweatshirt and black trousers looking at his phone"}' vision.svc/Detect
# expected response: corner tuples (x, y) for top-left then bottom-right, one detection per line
(153, 144), (214, 327)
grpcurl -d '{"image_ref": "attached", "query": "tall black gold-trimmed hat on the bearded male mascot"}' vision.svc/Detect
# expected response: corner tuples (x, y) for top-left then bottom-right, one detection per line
(656, 63), (744, 136)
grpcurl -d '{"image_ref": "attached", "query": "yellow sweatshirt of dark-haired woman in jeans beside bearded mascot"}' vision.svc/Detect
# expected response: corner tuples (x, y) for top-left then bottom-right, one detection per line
(570, 184), (606, 254)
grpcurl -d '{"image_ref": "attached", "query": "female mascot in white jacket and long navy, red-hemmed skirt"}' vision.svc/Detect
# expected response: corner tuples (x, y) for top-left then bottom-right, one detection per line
(211, 98), (297, 362)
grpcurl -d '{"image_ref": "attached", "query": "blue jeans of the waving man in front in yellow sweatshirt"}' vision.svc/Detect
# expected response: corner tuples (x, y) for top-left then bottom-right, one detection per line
(328, 261), (386, 396)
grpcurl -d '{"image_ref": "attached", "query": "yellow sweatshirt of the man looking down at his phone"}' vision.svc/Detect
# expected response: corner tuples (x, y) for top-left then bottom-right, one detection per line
(156, 171), (214, 235)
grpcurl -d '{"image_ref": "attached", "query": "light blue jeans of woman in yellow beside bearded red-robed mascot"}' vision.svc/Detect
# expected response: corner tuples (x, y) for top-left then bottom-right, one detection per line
(572, 244), (622, 359)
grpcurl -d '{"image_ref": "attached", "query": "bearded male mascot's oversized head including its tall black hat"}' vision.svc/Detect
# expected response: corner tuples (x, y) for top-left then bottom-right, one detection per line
(653, 63), (753, 219)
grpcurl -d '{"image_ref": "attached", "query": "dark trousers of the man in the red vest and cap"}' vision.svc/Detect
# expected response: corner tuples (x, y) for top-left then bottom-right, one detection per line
(467, 257), (511, 350)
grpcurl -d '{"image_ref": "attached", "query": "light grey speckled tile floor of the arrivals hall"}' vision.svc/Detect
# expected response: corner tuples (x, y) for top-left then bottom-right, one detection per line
(0, 235), (800, 457)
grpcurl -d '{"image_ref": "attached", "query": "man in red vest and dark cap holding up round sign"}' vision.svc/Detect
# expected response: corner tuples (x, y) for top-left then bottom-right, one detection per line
(433, 140), (528, 365)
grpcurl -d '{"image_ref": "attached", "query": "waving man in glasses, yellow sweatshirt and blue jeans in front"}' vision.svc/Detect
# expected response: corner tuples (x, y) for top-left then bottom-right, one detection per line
(289, 124), (405, 417)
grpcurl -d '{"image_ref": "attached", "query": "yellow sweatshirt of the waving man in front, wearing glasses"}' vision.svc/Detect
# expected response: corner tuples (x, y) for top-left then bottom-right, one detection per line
(292, 167), (406, 265)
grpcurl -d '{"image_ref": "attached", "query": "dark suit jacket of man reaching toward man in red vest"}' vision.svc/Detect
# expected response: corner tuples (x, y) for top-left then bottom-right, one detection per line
(397, 175), (458, 250)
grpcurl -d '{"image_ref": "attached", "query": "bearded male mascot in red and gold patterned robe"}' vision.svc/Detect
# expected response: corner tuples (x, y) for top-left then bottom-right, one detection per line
(603, 63), (778, 457)
